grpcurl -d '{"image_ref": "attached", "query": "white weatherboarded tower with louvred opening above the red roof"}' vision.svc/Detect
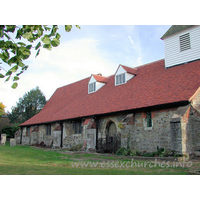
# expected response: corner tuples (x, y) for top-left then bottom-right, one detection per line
(161, 25), (200, 68)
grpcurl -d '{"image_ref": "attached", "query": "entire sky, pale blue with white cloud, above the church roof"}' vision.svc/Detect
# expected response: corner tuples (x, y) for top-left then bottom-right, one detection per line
(0, 25), (170, 111)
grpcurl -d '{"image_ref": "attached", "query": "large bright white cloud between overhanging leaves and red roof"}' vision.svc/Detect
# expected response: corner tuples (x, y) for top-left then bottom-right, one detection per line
(0, 39), (118, 111)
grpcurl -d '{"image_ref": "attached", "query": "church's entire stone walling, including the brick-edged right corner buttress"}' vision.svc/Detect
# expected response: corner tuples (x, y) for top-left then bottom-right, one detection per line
(18, 100), (200, 154)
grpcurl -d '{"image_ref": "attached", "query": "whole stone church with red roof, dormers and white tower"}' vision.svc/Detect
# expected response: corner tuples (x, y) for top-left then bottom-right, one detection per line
(16, 25), (200, 155)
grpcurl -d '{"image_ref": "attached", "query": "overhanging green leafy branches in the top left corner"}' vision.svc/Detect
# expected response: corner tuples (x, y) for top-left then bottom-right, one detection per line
(0, 25), (80, 89)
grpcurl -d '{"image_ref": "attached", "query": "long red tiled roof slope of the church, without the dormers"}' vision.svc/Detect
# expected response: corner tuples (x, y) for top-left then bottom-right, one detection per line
(21, 60), (200, 126)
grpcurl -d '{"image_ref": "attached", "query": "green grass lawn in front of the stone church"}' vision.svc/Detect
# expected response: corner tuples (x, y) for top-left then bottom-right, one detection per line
(0, 143), (196, 175)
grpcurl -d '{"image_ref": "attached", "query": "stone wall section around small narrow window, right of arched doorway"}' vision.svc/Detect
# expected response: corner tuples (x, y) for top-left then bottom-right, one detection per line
(130, 108), (177, 152)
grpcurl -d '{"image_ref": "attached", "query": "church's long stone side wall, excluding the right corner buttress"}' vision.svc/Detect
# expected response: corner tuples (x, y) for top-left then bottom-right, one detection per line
(19, 108), (177, 152)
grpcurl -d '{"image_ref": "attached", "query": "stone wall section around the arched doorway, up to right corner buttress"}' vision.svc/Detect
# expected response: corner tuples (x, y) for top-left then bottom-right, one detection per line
(99, 108), (177, 152)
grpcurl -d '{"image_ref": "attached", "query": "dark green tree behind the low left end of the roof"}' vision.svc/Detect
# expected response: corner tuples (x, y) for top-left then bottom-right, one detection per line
(8, 87), (46, 123)
